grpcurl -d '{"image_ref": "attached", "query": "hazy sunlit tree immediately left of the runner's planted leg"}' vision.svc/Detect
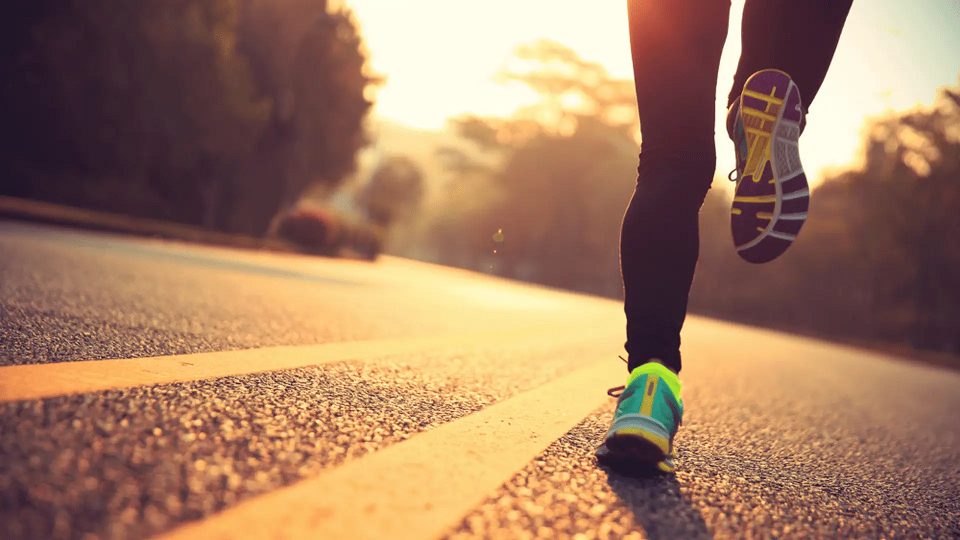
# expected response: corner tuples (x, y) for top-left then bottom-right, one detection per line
(422, 41), (638, 296)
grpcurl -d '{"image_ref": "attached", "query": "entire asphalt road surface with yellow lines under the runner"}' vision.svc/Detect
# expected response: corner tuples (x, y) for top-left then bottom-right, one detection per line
(0, 222), (960, 540)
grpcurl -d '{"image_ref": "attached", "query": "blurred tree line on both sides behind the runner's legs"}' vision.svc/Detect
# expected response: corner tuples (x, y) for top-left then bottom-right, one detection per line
(406, 41), (960, 353)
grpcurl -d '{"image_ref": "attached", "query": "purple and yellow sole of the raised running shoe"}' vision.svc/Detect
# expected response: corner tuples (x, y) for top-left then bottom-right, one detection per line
(730, 69), (810, 264)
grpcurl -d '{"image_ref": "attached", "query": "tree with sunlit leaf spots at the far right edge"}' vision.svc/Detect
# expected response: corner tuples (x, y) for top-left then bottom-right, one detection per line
(842, 82), (960, 352)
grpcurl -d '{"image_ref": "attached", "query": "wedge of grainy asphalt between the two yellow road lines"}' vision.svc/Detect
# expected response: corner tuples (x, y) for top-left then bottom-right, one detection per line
(0, 343), (602, 540)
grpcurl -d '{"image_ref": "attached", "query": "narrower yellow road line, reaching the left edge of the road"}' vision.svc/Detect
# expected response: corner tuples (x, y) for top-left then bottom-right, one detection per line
(0, 324), (620, 403)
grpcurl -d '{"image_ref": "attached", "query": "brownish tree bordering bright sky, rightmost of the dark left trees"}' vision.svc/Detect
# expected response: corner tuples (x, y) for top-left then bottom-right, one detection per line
(234, 0), (377, 233)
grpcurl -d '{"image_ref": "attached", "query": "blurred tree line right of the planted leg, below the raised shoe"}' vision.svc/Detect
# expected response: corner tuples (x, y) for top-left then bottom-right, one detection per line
(691, 86), (960, 354)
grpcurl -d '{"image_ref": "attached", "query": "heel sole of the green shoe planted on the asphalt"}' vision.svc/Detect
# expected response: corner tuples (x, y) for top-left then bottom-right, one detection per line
(604, 415), (670, 465)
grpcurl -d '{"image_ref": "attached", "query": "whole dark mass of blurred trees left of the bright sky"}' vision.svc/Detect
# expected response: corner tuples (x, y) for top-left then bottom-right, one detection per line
(0, 0), (376, 234)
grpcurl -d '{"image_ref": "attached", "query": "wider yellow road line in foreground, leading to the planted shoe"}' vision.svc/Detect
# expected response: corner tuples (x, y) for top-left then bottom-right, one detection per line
(160, 351), (626, 540)
